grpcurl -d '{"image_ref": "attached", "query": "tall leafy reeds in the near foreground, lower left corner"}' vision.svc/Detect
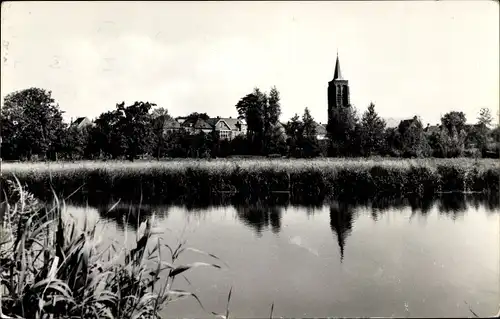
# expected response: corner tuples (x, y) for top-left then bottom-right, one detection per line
(0, 180), (221, 319)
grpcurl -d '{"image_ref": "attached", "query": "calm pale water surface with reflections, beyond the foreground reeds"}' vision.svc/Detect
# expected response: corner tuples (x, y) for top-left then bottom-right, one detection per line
(61, 196), (500, 318)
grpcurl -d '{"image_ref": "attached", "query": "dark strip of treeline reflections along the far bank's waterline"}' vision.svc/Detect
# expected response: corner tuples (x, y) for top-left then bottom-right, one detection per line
(67, 192), (500, 235)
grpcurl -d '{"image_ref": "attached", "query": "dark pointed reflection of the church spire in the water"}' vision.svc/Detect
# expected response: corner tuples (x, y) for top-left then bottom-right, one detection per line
(330, 202), (354, 262)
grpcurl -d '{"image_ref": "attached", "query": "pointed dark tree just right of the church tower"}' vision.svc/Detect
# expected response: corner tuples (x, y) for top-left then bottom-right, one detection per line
(361, 103), (385, 156)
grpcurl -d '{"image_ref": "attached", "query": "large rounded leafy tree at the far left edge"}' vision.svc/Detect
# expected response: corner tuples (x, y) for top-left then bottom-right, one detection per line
(1, 87), (66, 160)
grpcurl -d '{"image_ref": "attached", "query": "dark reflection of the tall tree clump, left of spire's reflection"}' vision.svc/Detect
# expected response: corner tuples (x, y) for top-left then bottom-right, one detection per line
(235, 203), (282, 236)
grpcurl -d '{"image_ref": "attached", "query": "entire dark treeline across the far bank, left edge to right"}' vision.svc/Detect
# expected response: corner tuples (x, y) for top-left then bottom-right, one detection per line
(1, 87), (500, 160)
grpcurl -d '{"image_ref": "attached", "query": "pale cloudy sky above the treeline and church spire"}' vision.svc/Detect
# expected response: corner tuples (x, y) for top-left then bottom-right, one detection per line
(1, 0), (500, 125)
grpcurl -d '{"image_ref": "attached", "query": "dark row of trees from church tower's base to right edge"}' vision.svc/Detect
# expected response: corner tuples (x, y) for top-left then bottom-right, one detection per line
(327, 103), (500, 157)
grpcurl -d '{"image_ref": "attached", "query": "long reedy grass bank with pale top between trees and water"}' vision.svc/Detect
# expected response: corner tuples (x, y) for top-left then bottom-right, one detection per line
(2, 158), (500, 200)
